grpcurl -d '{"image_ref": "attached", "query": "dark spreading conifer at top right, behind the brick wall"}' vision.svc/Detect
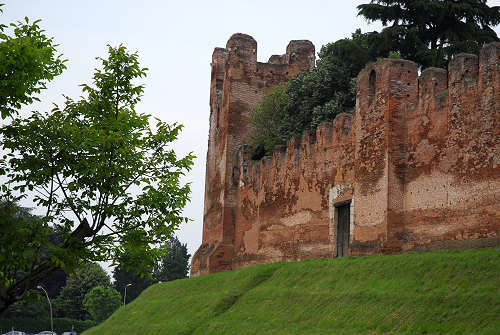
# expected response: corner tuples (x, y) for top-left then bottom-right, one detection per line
(358, 0), (500, 67)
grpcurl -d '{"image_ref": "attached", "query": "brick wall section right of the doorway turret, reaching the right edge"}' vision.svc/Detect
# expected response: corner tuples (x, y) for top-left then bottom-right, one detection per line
(392, 43), (500, 255)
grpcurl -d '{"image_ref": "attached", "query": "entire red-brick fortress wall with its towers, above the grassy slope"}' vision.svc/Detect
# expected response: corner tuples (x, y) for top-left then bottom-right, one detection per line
(191, 34), (500, 275)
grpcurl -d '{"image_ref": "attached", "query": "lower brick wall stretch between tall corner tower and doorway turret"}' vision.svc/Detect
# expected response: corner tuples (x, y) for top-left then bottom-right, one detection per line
(232, 114), (353, 268)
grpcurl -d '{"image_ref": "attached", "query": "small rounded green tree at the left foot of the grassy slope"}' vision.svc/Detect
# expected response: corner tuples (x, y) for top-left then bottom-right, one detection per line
(83, 286), (121, 323)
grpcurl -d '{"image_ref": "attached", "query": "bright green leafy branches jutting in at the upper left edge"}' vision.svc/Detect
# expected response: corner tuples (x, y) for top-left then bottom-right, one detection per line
(0, 4), (66, 119)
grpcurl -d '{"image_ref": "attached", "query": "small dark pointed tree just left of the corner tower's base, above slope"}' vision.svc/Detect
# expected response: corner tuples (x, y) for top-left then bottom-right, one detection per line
(153, 236), (191, 282)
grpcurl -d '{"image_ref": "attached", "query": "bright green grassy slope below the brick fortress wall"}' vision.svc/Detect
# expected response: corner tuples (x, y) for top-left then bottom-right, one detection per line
(84, 249), (500, 335)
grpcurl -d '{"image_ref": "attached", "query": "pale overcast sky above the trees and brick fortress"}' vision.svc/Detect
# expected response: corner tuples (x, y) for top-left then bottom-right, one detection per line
(0, 0), (500, 262)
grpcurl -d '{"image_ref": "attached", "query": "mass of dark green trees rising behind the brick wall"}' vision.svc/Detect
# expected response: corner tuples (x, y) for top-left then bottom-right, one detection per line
(251, 0), (500, 159)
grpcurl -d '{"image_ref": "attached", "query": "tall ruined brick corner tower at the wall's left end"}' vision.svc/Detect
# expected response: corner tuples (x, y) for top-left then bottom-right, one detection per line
(191, 34), (315, 275)
